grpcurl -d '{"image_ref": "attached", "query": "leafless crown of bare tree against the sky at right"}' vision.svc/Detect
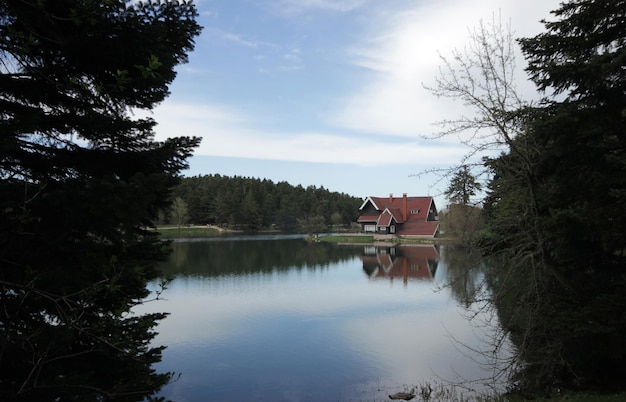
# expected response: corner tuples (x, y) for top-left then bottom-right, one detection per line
(412, 16), (531, 198)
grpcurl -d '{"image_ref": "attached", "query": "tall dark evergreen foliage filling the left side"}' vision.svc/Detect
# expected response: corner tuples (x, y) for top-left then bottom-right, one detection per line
(0, 0), (200, 401)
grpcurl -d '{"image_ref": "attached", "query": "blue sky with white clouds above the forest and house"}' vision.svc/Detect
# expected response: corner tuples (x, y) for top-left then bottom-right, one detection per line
(152, 0), (558, 209)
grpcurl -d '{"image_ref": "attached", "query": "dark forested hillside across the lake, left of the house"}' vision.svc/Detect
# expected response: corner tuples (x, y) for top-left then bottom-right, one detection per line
(162, 175), (363, 231)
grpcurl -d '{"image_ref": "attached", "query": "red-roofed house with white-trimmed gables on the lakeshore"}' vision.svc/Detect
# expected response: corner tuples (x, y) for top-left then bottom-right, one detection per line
(357, 194), (439, 237)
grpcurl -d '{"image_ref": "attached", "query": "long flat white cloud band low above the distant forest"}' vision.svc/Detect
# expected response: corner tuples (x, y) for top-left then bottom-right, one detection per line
(149, 102), (464, 166)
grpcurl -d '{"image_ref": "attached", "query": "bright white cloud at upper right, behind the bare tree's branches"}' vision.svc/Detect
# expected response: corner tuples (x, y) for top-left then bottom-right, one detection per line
(330, 0), (557, 137)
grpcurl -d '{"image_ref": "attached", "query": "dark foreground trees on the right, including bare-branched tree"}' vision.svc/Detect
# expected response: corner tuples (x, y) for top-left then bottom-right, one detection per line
(426, 0), (626, 395)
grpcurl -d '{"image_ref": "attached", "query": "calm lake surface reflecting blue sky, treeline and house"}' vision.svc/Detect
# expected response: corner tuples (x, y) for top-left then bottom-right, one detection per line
(134, 236), (504, 402)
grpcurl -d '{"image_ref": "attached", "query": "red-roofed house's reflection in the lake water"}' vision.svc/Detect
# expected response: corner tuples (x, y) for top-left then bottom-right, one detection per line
(361, 244), (439, 284)
